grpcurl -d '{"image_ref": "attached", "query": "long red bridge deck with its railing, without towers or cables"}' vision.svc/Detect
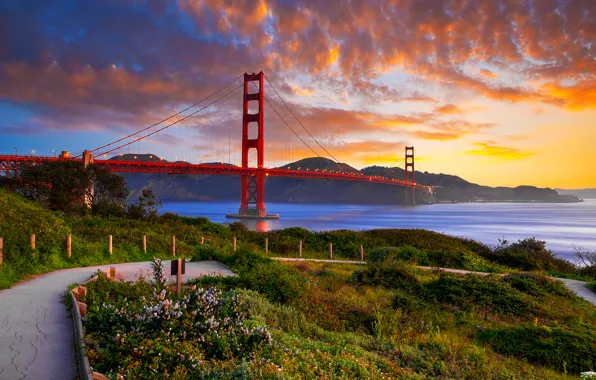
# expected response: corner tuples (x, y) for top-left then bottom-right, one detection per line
(0, 155), (428, 189)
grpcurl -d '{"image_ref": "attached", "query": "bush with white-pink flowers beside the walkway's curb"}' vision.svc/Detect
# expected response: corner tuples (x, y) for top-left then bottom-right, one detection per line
(85, 270), (273, 378)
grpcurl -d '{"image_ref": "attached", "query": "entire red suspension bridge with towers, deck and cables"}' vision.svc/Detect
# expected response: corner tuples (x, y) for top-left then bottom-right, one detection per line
(0, 72), (432, 218)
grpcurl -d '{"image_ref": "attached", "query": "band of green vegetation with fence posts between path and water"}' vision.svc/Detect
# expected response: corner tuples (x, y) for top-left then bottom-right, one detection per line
(0, 189), (596, 289)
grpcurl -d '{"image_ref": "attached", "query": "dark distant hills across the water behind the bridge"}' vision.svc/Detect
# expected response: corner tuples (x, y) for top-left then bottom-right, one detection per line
(112, 154), (579, 204)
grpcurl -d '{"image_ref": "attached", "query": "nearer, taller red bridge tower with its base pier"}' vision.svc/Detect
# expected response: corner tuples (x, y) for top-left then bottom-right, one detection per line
(226, 71), (279, 219)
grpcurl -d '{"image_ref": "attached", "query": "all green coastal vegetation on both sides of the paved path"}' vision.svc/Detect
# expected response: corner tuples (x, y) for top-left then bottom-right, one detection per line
(0, 179), (596, 379)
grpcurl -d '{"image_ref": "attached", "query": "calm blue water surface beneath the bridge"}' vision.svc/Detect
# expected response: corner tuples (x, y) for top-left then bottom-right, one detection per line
(162, 200), (596, 258)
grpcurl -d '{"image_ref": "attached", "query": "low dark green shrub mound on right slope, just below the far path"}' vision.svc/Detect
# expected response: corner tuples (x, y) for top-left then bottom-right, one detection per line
(424, 273), (541, 316)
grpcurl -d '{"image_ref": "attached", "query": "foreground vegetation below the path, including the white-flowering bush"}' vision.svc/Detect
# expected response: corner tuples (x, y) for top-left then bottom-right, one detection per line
(79, 246), (596, 379)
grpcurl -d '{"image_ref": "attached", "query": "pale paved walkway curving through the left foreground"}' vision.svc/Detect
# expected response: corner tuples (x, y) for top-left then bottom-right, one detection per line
(0, 261), (233, 380)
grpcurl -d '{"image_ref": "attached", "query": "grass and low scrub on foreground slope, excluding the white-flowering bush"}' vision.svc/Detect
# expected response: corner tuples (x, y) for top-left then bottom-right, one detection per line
(80, 251), (596, 379)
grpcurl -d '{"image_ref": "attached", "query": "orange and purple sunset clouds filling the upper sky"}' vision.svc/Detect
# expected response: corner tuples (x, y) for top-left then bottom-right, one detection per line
(0, 0), (596, 168)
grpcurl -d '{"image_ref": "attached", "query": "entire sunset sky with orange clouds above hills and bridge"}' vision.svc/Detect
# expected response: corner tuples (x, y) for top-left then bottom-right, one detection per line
(0, 0), (596, 188)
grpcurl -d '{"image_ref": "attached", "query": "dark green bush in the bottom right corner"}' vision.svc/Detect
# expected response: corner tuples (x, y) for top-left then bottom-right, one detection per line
(478, 324), (596, 374)
